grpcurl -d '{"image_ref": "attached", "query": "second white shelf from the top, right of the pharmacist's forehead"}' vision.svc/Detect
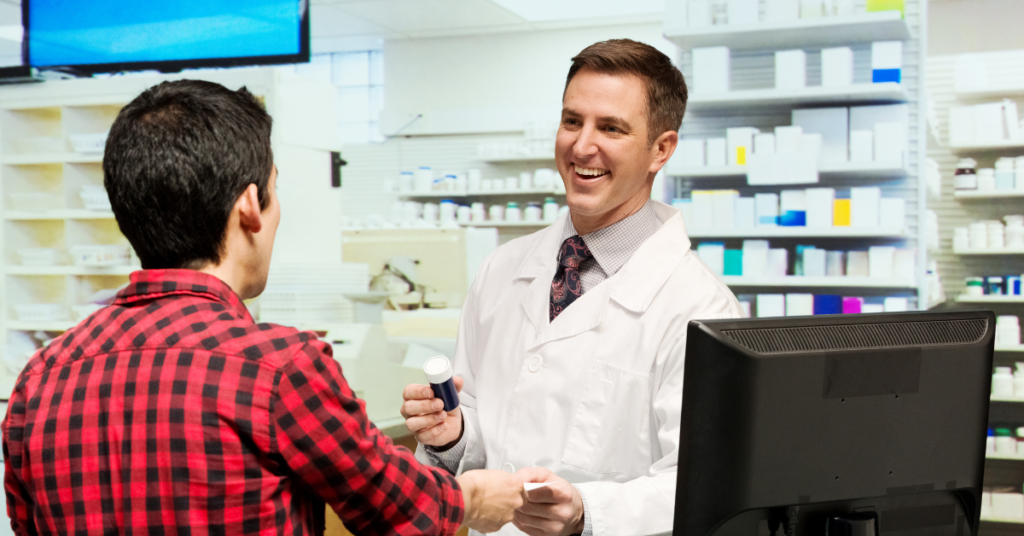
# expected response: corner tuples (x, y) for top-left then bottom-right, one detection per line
(686, 82), (907, 112)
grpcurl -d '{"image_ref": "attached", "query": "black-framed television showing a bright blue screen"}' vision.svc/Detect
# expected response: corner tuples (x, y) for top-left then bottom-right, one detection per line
(25, 0), (309, 72)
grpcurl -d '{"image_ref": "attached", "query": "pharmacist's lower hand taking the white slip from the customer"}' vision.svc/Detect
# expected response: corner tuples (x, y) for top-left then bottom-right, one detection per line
(512, 467), (584, 536)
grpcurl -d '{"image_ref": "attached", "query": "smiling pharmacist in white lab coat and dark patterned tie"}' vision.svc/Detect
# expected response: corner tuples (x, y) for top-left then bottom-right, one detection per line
(402, 40), (742, 536)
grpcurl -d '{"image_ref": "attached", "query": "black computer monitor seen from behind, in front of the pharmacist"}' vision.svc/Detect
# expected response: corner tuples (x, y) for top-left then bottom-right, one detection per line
(673, 311), (995, 536)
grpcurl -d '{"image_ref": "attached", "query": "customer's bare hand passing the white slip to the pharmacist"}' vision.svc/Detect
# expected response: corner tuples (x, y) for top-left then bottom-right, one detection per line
(456, 470), (526, 532)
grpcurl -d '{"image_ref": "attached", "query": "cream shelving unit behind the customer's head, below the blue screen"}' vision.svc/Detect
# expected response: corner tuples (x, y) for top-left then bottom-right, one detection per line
(0, 69), (341, 399)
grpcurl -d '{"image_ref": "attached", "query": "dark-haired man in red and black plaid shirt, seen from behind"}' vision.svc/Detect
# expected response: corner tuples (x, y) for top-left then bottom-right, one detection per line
(3, 80), (524, 535)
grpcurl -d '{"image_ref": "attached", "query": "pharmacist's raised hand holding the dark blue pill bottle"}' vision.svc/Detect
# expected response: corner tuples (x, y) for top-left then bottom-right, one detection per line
(401, 376), (463, 447)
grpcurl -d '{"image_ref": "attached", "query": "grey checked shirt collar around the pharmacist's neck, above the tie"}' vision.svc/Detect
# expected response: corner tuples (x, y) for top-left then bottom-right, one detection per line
(562, 201), (662, 278)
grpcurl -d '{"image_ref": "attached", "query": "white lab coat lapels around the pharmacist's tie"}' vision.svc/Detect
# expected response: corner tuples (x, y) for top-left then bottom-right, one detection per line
(513, 202), (690, 344)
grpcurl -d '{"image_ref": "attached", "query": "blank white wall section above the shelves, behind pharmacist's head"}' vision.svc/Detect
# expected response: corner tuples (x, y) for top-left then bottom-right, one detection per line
(382, 23), (677, 134)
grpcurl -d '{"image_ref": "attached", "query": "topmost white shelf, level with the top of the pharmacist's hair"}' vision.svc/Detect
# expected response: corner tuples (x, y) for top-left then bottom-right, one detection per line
(665, 11), (910, 50)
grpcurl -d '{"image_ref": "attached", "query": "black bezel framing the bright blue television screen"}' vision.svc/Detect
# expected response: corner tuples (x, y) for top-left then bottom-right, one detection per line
(22, 0), (310, 77)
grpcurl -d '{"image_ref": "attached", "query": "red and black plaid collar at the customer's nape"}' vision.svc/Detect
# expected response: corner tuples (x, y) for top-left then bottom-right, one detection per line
(114, 270), (252, 320)
